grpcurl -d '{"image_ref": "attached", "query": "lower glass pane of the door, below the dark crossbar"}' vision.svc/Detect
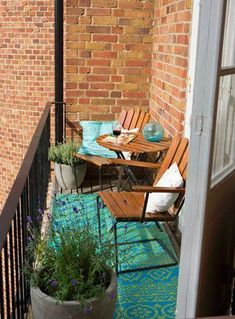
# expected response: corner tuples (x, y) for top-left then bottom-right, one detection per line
(212, 74), (235, 182)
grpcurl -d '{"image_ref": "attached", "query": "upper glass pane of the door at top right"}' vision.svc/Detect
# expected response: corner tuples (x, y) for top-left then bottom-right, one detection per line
(222, 0), (235, 67)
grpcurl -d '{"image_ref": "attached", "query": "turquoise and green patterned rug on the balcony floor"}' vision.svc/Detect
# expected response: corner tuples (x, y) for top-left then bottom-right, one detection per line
(53, 194), (178, 319)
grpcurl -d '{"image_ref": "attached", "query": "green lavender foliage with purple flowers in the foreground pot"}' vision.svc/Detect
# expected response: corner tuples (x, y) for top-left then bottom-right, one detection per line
(24, 222), (114, 307)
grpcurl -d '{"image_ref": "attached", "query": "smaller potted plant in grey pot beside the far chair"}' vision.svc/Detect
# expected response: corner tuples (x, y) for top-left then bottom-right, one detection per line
(48, 141), (87, 189)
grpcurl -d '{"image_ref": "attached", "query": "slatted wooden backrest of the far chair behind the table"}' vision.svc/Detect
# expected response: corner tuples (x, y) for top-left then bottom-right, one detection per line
(118, 109), (150, 131)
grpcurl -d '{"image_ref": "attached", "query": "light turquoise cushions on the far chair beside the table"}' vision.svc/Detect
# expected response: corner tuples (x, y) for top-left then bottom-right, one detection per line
(79, 121), (117, 158)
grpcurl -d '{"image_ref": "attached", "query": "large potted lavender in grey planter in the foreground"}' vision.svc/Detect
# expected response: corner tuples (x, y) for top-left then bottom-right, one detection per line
(24, 212), (117, 319)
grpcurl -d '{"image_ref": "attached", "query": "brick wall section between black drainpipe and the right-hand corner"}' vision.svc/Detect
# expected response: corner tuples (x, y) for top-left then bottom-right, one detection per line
(65, 0), (154, 135)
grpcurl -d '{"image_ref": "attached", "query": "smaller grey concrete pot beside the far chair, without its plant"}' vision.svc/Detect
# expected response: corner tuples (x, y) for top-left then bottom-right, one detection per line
(55, 163), (87, 189)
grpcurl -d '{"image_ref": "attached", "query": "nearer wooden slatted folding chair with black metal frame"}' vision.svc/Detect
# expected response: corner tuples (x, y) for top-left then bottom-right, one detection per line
(97, 138), (188, 273)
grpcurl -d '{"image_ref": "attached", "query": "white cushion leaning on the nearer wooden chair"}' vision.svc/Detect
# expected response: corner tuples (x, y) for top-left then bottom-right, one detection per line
(146, 163), (184, 213)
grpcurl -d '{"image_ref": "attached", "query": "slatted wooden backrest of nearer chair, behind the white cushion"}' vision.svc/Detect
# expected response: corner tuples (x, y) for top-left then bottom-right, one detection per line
(153, 137), (189, 215)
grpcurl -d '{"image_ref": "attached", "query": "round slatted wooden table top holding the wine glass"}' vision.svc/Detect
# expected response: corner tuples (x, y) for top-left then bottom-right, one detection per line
(96, 133), (170, 154)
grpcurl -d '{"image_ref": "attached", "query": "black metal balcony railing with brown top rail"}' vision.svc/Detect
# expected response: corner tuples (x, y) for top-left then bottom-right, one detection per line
(0, 103), (51, 319)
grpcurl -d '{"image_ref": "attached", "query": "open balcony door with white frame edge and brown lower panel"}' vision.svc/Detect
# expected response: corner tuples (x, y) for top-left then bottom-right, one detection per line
(176, 0), (235, 318)
